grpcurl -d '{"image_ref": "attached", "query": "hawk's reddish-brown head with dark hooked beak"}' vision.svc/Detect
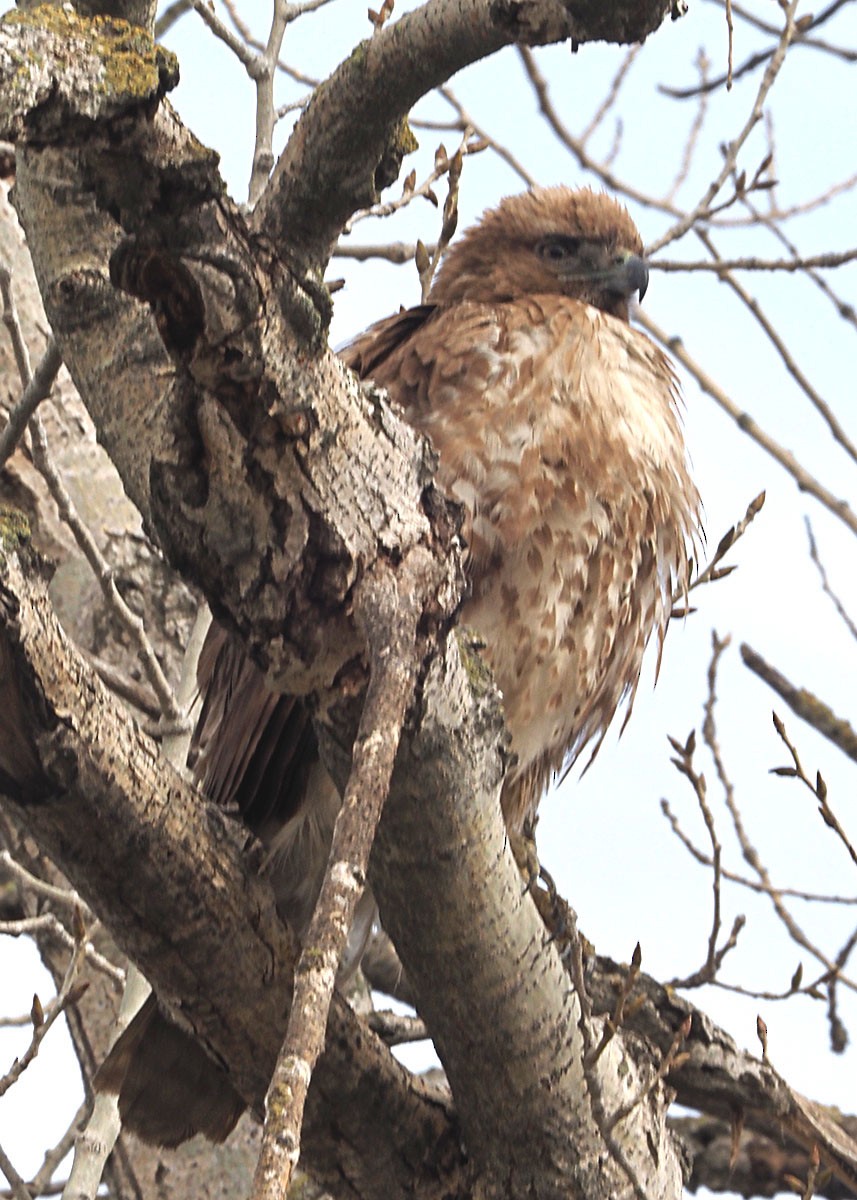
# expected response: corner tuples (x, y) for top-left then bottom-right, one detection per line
(431, 187), (648, 320)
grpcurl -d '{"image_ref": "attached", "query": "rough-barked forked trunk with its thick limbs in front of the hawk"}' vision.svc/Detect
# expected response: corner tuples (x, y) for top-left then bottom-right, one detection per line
(0, 0), (849, 1200)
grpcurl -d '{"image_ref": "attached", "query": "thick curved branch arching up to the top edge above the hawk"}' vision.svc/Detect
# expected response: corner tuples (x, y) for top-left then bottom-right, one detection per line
(253, 0), (670, 264)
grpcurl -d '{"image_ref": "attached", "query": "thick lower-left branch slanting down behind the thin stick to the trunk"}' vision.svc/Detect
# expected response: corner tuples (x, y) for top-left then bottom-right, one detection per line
(0, 545), (463, 1200)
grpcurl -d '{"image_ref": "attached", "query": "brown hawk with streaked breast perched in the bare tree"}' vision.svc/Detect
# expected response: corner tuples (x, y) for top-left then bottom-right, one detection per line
(101, 187), (699, 1145)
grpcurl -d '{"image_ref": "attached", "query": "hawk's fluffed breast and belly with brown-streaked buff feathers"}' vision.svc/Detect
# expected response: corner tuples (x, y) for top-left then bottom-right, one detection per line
(357, 295), (699, 824)
